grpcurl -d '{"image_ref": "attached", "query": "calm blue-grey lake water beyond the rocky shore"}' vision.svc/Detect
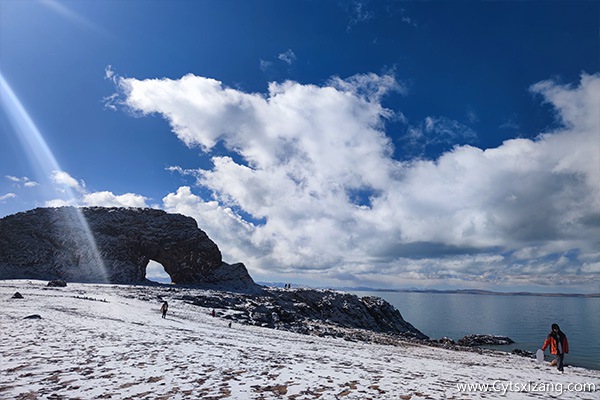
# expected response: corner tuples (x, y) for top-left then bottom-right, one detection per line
(353, 291), (600, 369)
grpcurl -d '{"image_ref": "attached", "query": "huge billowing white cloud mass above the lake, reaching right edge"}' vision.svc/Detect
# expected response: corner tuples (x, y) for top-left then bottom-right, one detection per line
(118, 74), (600, 285)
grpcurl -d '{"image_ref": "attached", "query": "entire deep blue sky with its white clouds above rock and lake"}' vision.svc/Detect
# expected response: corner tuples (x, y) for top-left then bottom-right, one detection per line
(0, 0), (600, 292)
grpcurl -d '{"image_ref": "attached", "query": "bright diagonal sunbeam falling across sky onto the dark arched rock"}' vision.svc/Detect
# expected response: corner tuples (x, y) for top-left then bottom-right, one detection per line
(0, 72), (109, 282)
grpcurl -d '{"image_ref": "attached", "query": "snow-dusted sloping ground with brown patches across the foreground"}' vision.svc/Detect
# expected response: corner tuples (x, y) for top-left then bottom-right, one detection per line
(0, 281), (600, 400)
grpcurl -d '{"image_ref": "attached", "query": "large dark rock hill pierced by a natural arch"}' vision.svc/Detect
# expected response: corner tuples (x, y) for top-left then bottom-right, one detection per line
(0, 207), (256, 289)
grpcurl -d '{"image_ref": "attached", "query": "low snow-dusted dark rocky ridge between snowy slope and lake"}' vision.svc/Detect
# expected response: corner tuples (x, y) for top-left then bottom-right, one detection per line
(180, 288), (428, 340)
